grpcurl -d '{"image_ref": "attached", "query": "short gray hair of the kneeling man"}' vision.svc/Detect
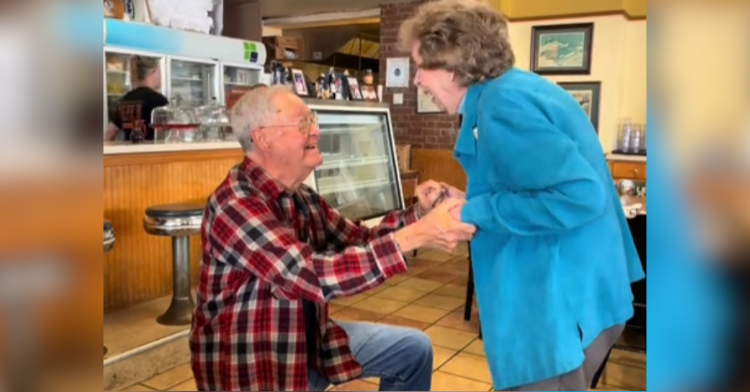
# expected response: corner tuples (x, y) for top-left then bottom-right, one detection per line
(230, 86), (291, 152)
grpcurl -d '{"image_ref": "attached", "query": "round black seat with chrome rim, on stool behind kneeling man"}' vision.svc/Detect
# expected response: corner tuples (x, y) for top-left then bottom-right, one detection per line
(143, 203), (206, 237)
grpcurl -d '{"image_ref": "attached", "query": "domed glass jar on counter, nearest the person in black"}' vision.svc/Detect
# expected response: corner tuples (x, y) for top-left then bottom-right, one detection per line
(151, 97), (200, 143)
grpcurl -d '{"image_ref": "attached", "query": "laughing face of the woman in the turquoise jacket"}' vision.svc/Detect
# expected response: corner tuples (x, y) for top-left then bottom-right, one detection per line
(411, 43), (465, 114)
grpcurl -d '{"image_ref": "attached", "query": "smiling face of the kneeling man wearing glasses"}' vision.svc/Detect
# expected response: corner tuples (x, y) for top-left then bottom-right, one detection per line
(256, 93), (323, 179)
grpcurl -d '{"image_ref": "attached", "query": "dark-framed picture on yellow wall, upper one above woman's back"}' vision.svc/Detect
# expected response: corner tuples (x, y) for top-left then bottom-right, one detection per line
(530, 23), (594, 75)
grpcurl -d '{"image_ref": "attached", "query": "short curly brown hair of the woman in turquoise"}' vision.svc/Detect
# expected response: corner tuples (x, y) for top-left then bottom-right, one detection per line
(399, 0), (516, 87)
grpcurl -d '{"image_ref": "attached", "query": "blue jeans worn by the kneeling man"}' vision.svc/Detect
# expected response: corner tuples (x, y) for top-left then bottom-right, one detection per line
(309, 321), (432, 391)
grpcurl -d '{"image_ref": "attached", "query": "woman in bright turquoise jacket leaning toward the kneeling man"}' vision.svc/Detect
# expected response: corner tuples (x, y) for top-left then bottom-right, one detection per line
(400, 0), (644, 391)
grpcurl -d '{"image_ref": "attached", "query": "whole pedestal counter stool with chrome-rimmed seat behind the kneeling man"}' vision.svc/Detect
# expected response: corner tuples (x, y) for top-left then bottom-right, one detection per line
(143, 203), (205, 325)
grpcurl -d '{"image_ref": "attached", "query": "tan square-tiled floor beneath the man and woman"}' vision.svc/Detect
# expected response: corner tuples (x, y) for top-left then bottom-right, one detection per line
(117, 249), (646, 391)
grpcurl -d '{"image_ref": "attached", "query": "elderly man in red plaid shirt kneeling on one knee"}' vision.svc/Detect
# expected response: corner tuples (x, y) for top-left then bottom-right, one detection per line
(190, 87), (474, 391)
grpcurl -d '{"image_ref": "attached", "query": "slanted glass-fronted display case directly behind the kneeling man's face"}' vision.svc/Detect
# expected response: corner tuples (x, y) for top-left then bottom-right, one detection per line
(306, 100), (404, 225)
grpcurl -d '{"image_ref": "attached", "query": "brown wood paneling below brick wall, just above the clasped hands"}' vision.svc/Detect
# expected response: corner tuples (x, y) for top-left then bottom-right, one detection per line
(411, 148), (466, 190)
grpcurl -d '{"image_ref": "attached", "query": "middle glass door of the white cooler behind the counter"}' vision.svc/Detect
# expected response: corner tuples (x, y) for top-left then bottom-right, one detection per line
(169, 57), (219, 107)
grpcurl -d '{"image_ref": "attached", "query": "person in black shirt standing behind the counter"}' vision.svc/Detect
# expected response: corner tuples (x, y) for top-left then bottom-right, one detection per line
(104, 56), (169, 141)
